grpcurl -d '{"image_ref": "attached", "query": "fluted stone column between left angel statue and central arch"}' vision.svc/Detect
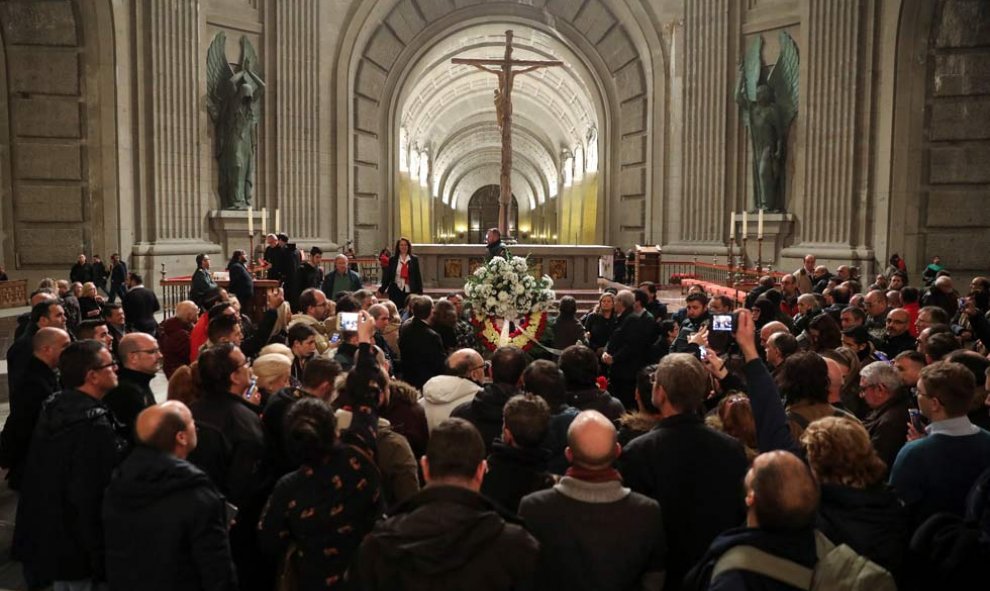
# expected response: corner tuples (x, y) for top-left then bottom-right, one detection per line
(267, 0), (324, 245)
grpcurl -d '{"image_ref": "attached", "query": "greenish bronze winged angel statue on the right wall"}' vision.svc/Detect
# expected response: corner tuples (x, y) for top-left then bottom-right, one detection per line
(736, 31), (799, 212)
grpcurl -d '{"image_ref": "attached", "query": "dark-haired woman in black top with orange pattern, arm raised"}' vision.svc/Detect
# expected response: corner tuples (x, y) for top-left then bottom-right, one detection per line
(258, 319), (383, 589)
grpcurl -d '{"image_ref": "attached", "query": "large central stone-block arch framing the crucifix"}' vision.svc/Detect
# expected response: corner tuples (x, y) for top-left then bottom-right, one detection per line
(338, 0), (665, 247)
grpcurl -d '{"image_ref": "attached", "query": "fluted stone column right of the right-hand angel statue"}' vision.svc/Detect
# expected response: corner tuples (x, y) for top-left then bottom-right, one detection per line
(782, 0), (874, 260)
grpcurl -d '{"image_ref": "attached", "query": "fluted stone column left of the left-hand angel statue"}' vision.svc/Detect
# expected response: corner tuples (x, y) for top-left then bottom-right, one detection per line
(131, 0), (220, 281)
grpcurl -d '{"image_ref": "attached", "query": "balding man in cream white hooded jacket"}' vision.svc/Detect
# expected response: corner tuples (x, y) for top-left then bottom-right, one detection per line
(419, 349), (489, 431)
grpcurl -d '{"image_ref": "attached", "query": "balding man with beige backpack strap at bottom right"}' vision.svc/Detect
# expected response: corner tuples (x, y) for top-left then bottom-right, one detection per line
(684, 451), (819, 589)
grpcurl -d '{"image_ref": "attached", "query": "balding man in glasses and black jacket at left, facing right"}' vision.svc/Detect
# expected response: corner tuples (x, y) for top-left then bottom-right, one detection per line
(103, 332), (163, 441)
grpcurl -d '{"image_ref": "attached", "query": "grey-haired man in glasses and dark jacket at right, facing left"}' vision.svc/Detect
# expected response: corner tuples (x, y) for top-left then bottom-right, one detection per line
(859, 361), (911, 470)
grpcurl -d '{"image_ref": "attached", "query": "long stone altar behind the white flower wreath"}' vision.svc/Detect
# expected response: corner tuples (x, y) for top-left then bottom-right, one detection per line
(413, 244), (615, 290)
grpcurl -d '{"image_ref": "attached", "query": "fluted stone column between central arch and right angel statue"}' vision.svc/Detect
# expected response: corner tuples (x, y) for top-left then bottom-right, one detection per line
(664, 0), (739, 253)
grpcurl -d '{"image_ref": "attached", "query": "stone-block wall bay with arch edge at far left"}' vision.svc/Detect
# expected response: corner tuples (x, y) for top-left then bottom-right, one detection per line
(0, 0), (119, 279)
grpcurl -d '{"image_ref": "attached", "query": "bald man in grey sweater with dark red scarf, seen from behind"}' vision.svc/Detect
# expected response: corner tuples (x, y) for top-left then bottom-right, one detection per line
(519, 410), (667, 591)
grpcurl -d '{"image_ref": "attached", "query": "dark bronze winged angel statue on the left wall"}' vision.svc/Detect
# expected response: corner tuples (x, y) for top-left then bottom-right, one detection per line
(206, 31), (265, 209)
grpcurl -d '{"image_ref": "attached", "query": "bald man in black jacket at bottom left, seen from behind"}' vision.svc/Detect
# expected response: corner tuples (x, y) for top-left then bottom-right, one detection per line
(103, 400), (237, 591)
